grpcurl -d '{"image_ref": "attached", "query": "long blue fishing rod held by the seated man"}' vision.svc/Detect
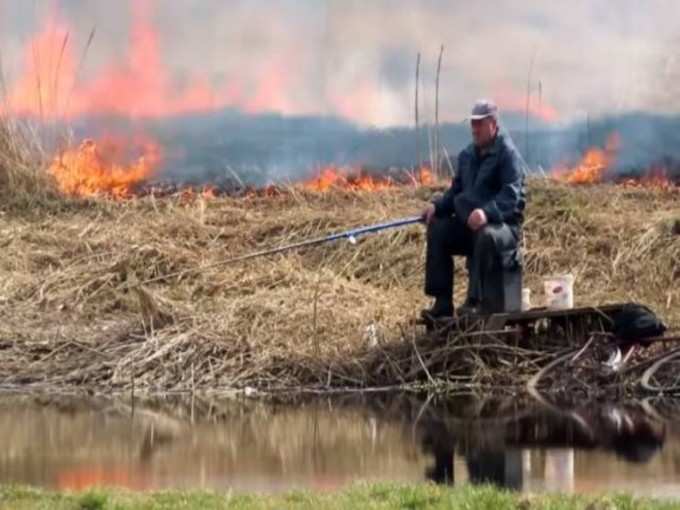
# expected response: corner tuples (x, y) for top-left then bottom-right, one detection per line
(141, 216), (424, 284)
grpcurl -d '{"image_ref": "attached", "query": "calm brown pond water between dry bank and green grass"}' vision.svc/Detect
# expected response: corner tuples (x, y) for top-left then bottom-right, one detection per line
(0, 394), (680, 497)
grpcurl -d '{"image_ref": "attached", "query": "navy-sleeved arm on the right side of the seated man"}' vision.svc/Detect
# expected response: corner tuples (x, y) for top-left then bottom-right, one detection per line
(481, 146), (524, 223)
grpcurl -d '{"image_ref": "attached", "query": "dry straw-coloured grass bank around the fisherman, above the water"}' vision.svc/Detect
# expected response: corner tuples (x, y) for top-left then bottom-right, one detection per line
(0, 181), (680, 391)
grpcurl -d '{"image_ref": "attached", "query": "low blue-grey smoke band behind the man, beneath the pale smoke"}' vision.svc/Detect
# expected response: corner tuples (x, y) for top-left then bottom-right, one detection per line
(49, 109), (680, 186)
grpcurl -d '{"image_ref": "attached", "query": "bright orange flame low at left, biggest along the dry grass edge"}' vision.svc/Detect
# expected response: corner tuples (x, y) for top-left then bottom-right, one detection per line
(49, 139), (161, 198)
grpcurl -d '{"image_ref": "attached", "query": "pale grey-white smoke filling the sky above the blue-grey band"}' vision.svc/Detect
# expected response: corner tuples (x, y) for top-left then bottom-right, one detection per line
(0, 0), (680, 127)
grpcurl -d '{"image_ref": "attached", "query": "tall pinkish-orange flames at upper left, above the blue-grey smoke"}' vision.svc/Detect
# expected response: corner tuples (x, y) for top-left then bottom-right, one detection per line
(0, 1), (244, 118)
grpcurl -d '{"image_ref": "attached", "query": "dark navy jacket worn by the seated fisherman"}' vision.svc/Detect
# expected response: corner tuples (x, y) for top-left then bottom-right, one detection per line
(434, 130), (526, 226)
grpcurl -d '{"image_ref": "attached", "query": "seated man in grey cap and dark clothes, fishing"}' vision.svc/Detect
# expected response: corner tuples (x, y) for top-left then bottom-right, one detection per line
(422, 100), (526, 319)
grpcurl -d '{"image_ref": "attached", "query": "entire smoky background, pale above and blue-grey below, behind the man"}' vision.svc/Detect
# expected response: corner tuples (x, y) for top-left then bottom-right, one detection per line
(0, 0), (680, 184)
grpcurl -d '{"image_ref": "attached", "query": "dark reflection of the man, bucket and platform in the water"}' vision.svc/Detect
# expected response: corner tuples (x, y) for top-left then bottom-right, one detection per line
(418, 396), (668, 492)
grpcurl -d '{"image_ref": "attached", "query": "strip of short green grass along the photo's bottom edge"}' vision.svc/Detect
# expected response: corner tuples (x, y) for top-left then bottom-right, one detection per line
(0, 484), (680, 510)
